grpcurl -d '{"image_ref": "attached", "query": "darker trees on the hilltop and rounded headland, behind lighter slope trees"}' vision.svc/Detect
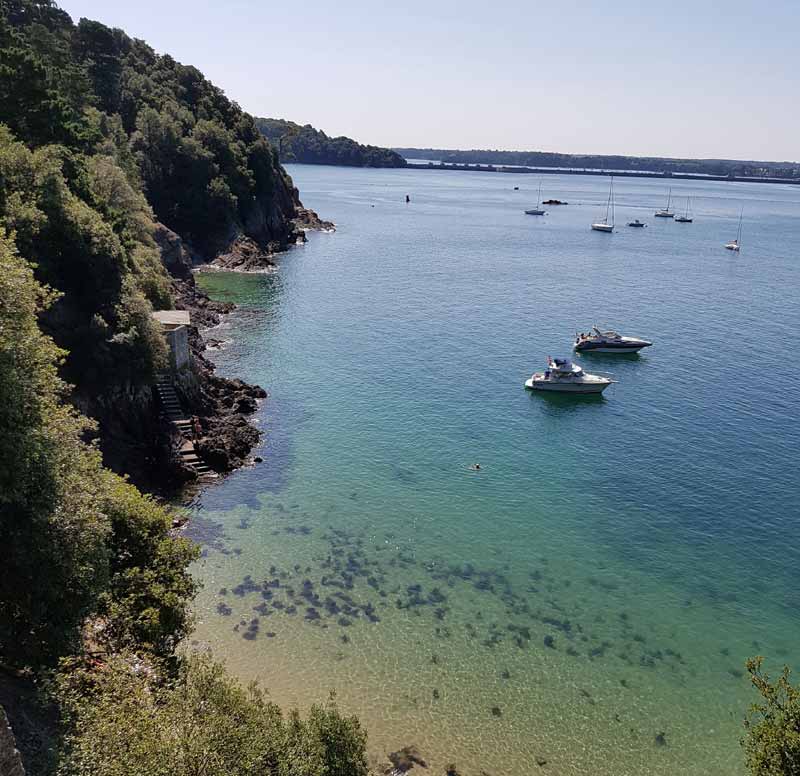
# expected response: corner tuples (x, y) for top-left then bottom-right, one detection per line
(0, 0), (295, 255)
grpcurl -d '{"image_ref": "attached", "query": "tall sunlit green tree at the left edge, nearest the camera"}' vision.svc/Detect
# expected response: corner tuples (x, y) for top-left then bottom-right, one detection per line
(0, 237), (110, 664)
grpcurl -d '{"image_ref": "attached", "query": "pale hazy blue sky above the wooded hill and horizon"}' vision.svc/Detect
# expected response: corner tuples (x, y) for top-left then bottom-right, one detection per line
(60, 0), (800, 160)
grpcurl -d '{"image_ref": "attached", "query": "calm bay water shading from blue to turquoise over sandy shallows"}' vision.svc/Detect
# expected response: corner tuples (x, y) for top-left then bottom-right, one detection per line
(190, 167), (800, 776)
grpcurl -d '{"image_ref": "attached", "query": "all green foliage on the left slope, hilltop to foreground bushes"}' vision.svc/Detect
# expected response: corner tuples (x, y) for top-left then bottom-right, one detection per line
(0, 6), (366, 776)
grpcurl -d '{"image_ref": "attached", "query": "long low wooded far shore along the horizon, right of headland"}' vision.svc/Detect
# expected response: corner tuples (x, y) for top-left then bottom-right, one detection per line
(394, 148), (800, 179)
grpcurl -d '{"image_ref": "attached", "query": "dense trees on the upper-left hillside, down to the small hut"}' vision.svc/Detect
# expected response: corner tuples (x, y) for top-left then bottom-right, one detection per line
(0, 0), (296, 388)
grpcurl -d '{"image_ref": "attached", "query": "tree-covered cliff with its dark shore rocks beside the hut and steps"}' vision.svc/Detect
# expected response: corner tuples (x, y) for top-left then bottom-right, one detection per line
(0, 0), (315, 488)
